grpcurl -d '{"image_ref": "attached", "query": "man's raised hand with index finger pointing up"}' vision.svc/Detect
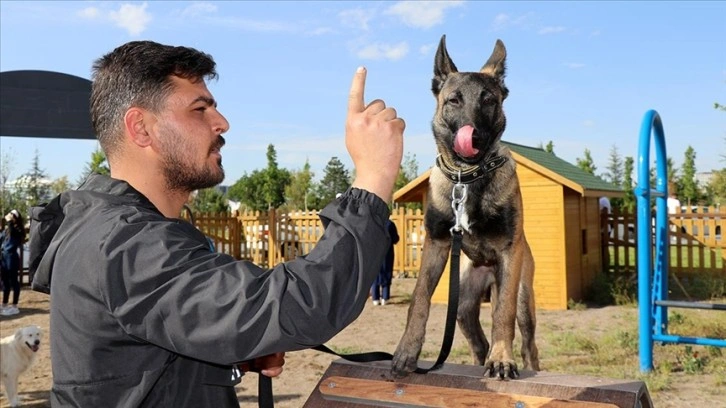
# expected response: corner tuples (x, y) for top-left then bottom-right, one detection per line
(345, 67), (406, 203)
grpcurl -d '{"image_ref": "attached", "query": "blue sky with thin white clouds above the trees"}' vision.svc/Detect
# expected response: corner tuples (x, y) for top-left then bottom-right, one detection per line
(0, 1), (726, 185)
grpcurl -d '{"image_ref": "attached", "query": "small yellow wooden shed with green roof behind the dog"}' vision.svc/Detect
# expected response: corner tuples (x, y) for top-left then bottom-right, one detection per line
(393, 142), (624, 310)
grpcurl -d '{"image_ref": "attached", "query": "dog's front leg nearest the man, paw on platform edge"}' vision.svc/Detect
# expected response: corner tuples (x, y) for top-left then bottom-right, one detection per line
(391, 234), (451, 377)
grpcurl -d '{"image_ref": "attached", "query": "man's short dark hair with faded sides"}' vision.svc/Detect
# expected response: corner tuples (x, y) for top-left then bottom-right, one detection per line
(91, 41), (217, 157)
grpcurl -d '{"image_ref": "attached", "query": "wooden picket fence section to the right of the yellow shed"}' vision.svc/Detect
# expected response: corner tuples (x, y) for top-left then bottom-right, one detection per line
(603, 207), (726, 278)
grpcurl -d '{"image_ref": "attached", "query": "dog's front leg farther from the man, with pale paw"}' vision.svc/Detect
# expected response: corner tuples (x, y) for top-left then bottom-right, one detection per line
(484, 245), (522, 379)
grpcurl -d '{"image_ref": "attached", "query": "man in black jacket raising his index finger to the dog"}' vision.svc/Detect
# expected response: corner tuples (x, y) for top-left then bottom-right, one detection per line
(31, 41), (405, 407)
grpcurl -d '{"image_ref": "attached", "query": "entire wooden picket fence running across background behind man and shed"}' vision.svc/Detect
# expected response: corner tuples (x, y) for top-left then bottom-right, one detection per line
(21, 207), (726, 283)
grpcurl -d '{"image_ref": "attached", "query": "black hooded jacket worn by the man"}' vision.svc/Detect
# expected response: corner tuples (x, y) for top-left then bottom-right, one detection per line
(30, 175), (389, 407)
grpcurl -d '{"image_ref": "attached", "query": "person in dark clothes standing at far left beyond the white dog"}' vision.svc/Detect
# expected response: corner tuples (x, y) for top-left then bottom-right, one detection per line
(0, 210), (25, 316)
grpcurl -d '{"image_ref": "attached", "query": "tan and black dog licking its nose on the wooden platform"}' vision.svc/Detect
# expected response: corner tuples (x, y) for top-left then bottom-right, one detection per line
(391, 35), (539, 379)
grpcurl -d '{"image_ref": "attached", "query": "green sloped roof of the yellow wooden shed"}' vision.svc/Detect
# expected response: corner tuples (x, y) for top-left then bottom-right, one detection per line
(393, 141), (625, 203)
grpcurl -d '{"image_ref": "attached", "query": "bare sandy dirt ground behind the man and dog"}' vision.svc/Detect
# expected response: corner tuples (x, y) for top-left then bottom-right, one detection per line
(0, 279), (726, 408)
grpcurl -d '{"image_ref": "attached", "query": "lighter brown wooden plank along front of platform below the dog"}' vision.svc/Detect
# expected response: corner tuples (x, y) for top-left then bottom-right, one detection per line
(318, 376), (618, 408)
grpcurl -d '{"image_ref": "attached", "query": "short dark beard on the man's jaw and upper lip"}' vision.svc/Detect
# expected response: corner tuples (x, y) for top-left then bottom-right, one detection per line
(162, 136), (225, 192)
